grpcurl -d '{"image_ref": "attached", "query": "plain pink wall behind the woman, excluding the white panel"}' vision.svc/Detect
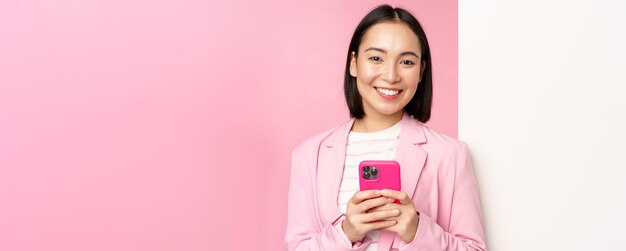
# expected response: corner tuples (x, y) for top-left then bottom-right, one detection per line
(0, 0), (457, 250)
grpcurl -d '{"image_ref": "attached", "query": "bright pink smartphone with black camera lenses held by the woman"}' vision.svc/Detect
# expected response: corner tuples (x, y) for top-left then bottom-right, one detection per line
(359, 160), (400, 203)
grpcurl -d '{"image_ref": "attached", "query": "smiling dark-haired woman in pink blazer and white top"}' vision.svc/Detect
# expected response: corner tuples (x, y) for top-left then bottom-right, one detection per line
(285, 5), (486, 250)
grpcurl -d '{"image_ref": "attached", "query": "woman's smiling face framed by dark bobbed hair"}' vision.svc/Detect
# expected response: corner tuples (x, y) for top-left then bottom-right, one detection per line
(350, 22), (424, 116)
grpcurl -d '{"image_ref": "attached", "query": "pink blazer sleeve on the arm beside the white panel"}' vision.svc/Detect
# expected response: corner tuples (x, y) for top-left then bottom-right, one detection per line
(400, 142), (487, 251)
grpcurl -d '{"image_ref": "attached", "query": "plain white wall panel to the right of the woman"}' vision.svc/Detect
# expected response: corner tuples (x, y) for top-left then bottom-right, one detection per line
(459, 0), (626, 251)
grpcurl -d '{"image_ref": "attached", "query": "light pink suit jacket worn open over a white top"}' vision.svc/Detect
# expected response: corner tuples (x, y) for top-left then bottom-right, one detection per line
(285, 113), (486, 251)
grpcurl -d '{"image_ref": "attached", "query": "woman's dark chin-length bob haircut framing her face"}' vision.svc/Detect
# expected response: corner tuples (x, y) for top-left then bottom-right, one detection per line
(343, 5), (433, 123)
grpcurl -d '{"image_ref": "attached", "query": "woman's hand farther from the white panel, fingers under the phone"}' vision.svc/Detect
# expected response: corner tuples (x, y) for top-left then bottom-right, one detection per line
(342, 190), (400, 243)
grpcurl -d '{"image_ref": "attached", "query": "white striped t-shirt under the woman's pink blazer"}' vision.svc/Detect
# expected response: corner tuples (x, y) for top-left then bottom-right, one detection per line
(337, 122), (401, 251)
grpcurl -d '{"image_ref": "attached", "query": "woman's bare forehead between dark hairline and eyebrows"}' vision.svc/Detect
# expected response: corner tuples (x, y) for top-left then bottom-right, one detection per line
(359, 22), (421, 54)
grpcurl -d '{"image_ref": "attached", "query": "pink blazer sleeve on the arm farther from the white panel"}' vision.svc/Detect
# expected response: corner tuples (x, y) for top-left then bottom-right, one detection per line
(285, 148), (369, 250)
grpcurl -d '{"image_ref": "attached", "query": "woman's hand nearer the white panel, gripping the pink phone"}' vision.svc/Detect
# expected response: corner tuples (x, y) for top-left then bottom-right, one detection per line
(370, 189), (419, 243)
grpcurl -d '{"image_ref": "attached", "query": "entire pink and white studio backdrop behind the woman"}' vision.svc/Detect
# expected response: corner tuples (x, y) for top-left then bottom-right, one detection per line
(0, 0), (626, 251)
